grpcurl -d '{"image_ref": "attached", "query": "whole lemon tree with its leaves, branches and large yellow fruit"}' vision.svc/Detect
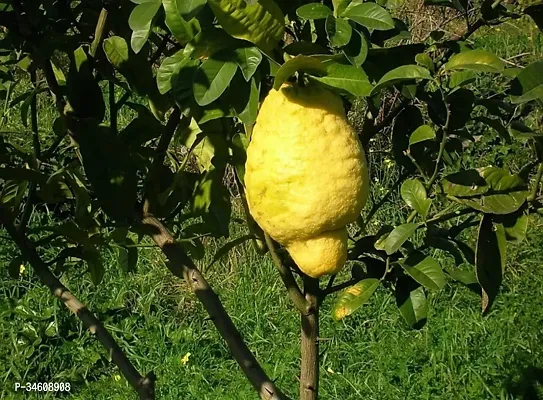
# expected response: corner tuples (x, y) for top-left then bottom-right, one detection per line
(0, 0), (543, 400)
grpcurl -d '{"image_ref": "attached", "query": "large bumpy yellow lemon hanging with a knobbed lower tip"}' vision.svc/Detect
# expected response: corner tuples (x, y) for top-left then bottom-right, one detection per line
(245, 84), (369, 278)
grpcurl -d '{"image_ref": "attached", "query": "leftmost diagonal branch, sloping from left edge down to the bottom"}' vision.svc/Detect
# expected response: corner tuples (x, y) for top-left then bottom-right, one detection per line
(0, 204), (155, 400)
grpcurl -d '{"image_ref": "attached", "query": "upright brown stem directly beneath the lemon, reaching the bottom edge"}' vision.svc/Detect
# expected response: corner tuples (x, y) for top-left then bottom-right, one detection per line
(300, 277), (320, 400)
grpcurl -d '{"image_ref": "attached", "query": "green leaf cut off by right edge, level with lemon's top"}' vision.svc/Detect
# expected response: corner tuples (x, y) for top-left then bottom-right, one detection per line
(510, 60), (543, 104)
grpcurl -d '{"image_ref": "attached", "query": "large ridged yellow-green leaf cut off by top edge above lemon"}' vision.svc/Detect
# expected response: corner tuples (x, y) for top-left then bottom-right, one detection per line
(208, 0), (285, 53)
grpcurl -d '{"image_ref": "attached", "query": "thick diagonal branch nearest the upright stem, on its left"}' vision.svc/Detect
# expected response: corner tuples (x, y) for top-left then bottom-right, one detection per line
(142, 214), (287, 400)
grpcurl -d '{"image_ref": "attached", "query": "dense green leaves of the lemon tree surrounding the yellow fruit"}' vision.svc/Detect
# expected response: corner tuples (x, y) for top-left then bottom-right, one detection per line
(0, 0), (543, 398)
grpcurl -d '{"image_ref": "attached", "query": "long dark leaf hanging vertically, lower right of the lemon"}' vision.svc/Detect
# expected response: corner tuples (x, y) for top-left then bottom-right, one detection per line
(475, 214), (506, 312)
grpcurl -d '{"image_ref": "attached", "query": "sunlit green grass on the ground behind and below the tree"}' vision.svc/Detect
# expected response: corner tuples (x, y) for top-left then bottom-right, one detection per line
(0, 14), (543, 400)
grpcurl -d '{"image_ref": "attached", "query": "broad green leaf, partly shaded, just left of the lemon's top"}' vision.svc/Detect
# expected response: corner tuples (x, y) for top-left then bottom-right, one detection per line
(193, 58), (238, 106)
